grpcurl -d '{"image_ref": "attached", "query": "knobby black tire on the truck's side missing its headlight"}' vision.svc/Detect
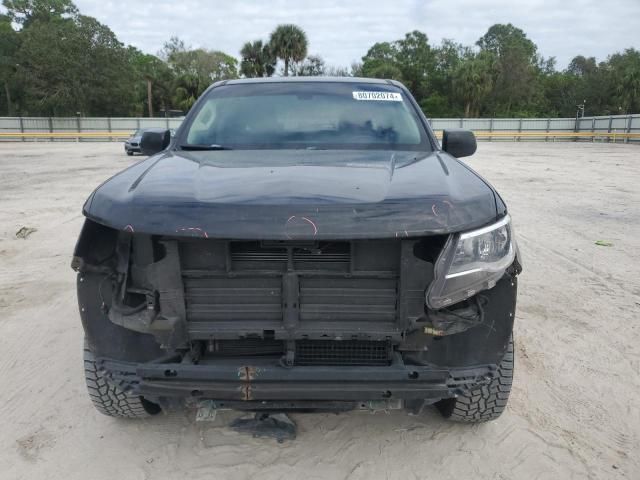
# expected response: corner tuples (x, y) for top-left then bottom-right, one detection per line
(84, 341), (160, 418)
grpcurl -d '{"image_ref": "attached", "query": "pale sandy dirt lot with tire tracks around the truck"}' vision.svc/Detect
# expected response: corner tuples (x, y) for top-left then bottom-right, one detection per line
(0, 143), (640, 480)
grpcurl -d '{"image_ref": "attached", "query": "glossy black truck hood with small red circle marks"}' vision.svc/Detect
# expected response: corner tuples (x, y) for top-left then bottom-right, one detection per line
(84, 150), (498, 240)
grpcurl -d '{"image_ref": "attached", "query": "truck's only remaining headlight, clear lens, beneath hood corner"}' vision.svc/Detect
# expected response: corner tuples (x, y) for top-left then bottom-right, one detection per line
(427, 215), (516, 310)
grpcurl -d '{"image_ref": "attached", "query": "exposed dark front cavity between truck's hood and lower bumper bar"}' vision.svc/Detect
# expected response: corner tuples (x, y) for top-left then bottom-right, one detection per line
(73, 220), (515, 372)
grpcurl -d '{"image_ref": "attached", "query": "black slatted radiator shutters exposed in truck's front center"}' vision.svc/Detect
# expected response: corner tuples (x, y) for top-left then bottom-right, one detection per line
(181, 241), (400, 324)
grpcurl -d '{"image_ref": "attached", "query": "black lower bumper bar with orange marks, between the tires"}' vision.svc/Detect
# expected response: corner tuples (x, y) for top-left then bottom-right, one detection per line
(98, 355), (497, 408)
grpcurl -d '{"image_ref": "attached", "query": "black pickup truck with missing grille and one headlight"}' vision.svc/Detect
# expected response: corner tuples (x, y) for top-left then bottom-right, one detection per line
(72, 77), (521, 422)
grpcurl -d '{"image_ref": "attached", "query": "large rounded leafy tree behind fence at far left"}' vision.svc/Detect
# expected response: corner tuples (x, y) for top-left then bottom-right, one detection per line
(17, 15), (132, 115)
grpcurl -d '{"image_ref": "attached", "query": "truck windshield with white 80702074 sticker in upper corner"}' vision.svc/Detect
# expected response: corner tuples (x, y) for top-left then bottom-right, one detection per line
(182, 82), (431, 150)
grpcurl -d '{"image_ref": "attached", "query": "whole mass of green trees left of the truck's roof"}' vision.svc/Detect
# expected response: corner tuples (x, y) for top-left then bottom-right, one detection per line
(0, 0), (238, 116)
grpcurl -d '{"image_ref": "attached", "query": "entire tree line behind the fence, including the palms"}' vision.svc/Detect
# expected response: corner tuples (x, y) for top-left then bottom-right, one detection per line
(0, 0), (640, 117)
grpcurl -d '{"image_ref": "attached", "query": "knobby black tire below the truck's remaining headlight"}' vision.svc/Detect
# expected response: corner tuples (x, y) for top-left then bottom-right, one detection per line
(436, 336), (513, 423)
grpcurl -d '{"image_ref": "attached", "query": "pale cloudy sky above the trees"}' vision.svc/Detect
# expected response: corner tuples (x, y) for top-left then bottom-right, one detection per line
(75, 0), (640, 68)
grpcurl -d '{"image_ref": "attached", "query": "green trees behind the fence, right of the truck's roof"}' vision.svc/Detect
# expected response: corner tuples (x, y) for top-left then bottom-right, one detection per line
(354, 24), (640, 117)
